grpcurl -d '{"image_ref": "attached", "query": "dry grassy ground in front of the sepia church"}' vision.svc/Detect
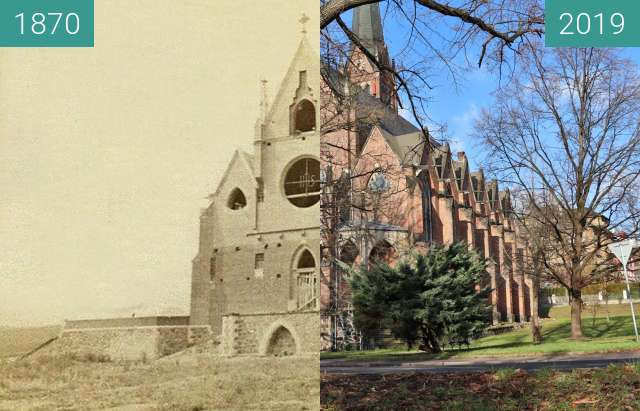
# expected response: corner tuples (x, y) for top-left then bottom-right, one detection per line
(0, 354), (320, 411)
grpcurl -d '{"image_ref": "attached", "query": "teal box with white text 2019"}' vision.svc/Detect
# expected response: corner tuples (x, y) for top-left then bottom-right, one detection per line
(544, 0), (640, 47)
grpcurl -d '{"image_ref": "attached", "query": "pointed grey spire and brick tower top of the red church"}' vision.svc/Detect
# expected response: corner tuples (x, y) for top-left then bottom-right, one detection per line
(348, 3), (398, 111)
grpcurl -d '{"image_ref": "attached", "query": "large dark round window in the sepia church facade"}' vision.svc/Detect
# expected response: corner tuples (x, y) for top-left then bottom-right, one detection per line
(284, 158), (320, 208)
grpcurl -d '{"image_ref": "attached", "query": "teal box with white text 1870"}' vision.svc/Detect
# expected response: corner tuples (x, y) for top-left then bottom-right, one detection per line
(0, 0), (94, 47)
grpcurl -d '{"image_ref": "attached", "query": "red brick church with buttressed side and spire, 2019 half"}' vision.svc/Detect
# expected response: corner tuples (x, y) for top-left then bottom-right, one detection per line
(321, 3), (533, 349)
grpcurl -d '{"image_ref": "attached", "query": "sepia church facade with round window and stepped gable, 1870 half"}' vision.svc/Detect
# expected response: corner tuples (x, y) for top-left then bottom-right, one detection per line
(190, 23), (320, 355)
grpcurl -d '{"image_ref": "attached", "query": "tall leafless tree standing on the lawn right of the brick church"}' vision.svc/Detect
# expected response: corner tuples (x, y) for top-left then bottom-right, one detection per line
(477, 46), (640, 339)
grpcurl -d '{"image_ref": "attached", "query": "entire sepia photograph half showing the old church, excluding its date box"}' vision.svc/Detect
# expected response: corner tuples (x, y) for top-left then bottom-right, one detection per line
(0, 0), (320, 411)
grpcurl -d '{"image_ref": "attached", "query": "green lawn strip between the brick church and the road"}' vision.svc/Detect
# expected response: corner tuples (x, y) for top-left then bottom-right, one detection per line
(322, 312), (640, 361)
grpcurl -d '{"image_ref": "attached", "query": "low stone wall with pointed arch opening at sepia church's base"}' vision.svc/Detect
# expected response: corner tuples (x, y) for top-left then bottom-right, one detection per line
(221, 311), (320, 355)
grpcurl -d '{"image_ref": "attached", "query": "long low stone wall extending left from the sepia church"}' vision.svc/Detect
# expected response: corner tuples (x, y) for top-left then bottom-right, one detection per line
(40, 324), (211, 361)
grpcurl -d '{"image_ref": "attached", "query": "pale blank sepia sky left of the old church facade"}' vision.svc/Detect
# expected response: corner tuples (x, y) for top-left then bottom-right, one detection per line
(0, 0), (319, 325)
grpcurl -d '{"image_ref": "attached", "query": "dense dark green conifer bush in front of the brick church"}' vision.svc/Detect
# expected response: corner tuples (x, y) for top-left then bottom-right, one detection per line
(350, 242), (491, 352)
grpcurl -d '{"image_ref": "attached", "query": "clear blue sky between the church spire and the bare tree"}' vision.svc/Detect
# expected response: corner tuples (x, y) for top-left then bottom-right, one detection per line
(345, 2), (640, 168)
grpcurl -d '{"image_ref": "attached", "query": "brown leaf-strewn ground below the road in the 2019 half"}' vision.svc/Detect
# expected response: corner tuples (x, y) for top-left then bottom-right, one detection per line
(321, 364), (640, 411)
